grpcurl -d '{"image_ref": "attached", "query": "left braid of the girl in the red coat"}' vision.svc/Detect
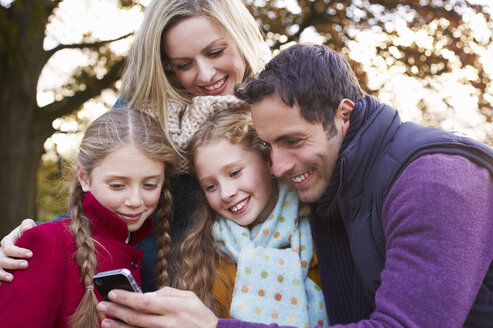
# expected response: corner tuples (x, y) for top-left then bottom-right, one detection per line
(70, 180), (102, 328)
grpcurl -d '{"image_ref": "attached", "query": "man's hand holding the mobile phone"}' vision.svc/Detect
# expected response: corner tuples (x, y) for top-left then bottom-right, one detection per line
(98, 287), (219, 328)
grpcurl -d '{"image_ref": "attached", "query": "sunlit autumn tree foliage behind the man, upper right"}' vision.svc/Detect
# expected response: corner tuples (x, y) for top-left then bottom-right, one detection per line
(247, 0), (493, 145)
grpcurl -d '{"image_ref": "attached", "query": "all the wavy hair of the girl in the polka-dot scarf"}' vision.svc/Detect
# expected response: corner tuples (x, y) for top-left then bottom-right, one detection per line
(174, 104), (269, 315)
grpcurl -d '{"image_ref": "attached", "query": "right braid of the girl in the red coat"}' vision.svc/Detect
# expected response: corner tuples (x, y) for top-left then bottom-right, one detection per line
(156, 175), (173, 288)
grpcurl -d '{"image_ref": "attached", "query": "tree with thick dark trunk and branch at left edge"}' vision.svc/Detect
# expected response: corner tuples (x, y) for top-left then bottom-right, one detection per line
(0, 0), (136, 236)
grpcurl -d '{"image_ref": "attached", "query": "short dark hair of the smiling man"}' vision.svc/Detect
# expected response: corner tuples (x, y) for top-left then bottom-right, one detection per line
(235, 44), (364, 136)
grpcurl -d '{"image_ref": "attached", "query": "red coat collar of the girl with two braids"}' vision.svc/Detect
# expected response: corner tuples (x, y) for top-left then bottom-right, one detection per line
(82, 192), (153, 246)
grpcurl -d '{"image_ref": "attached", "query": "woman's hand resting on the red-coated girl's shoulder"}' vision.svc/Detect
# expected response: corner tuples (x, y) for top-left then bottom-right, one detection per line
(0, 219), (36, 282)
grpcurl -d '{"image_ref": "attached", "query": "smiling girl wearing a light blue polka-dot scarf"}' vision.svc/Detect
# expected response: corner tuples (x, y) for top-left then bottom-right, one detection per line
(168, 97), (328, 327)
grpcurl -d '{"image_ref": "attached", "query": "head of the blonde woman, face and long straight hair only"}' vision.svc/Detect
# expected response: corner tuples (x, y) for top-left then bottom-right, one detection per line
(117, 0), (269, 142)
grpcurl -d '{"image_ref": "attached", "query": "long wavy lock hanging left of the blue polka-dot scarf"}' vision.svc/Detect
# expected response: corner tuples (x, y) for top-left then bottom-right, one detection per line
(175, 200), (220, 315)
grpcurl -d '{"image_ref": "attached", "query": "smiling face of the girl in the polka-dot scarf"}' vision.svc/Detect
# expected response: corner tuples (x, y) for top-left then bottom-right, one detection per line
(194, 140), (277, 226)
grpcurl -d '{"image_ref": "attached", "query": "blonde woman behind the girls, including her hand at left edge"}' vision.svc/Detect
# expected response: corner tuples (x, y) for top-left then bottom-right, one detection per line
(0, 0), (269, 291)
